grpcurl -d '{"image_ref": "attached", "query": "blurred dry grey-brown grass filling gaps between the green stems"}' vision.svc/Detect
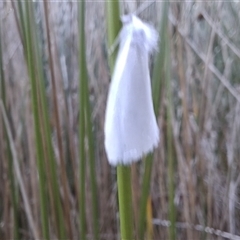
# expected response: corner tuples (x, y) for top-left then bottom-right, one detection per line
(0, 1), (240, 240)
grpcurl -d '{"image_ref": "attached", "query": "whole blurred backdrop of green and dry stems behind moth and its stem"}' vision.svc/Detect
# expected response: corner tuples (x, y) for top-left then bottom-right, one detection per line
(0, 0), (240, 240)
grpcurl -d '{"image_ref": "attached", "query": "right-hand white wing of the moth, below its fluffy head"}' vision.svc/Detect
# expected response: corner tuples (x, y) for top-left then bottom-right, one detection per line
(117, 44), (159, 164)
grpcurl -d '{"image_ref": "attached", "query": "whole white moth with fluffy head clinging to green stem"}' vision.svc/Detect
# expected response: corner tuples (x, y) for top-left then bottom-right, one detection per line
(104, 15), (159, 165)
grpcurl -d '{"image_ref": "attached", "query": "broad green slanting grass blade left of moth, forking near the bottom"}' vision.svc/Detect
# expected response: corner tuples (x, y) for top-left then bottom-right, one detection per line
(25, 2), (65, 239)
